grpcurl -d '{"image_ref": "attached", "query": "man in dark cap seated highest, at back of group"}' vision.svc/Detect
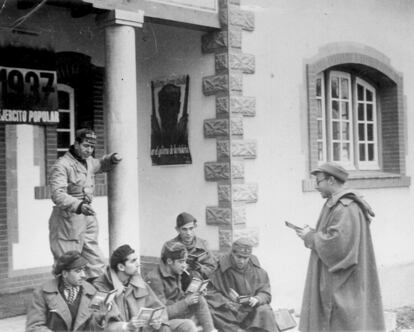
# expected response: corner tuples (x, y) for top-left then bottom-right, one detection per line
(164, 212), (217, 289)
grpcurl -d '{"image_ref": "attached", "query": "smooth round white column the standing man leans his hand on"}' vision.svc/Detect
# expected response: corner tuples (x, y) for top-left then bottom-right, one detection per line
(98, 9), (144, 256)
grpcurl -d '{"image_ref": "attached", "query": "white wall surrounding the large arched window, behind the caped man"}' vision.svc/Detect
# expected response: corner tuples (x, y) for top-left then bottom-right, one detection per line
(242, 0), (414, 309)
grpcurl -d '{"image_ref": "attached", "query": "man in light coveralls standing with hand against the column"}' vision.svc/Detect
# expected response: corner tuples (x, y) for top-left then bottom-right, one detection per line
(49, 129), (121, 278)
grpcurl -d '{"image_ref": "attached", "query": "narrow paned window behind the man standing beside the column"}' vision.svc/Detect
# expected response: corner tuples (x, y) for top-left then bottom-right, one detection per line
(56, 84), (75, 158)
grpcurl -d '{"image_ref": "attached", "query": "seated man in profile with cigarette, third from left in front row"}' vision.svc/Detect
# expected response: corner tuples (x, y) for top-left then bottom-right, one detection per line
(147, 241), (217, 332)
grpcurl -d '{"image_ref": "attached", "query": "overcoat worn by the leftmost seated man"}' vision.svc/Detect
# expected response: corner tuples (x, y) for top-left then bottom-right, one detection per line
(26, 279), (102, 332)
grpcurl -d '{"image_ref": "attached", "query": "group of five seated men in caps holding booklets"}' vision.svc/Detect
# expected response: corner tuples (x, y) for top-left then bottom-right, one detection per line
(26, 212), (278, 332)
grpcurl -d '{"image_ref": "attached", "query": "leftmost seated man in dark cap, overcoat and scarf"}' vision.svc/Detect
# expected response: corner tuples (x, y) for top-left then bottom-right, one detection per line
(26, 251), (104, 332)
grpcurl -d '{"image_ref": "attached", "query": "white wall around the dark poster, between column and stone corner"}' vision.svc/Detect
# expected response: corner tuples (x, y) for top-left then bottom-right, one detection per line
(137, 23), (218, 256)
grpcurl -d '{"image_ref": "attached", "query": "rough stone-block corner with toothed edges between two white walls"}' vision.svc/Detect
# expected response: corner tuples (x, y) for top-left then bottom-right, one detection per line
(202, 0), (258, 251)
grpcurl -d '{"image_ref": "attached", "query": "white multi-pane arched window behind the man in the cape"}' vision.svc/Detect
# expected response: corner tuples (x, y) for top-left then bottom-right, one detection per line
(315, 71), (379, 170)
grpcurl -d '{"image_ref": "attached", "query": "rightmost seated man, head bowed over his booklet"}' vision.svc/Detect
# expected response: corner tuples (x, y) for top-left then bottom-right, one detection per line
(206, 238), (278, 332)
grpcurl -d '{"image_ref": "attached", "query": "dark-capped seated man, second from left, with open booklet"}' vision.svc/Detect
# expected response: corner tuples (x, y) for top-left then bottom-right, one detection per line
(94, 244), (170, 332)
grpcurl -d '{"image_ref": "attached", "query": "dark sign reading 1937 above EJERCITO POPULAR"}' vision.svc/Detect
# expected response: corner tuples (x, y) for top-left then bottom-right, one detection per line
(0, 66), (59, 125)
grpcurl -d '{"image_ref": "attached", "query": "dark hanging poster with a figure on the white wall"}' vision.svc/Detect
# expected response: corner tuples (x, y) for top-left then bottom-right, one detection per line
(151, 75), (191, 165)
